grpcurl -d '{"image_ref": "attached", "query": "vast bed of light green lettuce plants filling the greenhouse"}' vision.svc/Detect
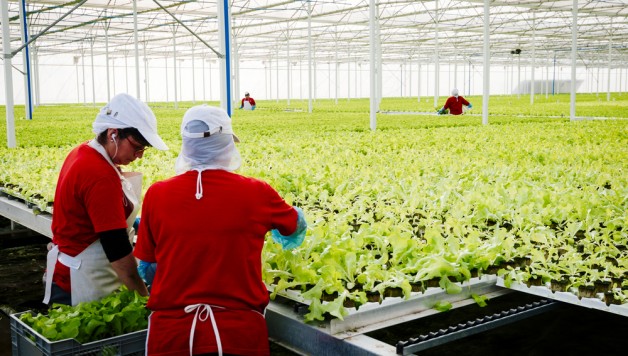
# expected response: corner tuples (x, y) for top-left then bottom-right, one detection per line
(0, 96), (628, 328)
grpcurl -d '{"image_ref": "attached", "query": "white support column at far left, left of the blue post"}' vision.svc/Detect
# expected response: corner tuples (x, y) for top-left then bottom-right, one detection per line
(0, 0), (17, 148)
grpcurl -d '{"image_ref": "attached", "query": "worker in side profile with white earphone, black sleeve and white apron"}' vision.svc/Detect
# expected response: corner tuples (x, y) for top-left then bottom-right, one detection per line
(44, 94), (168, 305)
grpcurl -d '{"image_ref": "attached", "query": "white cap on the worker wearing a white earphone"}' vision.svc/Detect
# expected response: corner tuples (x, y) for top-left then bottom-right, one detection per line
(92, 93), (168, 151)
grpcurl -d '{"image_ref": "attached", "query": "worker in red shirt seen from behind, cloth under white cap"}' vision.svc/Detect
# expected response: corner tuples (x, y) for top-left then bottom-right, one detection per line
(134, 105), (307, 355)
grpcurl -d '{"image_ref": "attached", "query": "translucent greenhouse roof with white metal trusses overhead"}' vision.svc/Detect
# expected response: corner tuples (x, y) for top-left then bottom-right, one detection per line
(4, 0), (628, 66)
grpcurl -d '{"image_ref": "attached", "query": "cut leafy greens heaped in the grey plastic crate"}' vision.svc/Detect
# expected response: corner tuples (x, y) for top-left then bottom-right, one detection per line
(20, 286), (149, 344)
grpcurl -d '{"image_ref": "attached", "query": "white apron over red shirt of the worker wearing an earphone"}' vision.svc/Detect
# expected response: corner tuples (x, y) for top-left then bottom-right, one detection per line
(43, 140), (142, 305)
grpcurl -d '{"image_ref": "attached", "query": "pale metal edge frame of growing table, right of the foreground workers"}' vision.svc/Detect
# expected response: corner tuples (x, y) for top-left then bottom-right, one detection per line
(266, 276), (512, 355)
